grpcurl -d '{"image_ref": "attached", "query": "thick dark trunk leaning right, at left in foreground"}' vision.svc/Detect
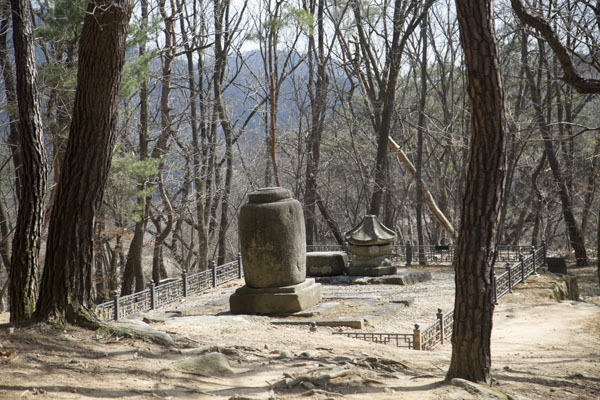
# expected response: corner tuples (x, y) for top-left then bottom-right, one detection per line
(36, 0), (133, 325)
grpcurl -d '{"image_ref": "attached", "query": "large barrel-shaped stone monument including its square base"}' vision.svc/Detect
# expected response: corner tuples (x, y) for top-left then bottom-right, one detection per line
(229, 187), (321, 314)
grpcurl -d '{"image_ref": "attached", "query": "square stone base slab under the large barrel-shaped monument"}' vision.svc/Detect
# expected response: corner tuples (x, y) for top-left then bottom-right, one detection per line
(229, 279), (321, 314)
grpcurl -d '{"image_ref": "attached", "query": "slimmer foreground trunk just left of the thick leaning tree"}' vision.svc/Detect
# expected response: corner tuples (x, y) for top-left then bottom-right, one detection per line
(9, 0), (47, 322)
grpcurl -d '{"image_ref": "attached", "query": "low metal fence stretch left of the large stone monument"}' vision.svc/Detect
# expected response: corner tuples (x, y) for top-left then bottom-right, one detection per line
(96, 256), (243, 321)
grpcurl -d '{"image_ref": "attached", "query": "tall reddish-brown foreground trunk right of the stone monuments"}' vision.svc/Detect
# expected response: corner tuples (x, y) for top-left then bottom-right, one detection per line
(446, 0), (506, 383)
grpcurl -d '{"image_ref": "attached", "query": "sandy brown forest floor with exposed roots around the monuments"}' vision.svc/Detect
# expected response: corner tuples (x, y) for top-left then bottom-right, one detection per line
(0, 267), (600, 400)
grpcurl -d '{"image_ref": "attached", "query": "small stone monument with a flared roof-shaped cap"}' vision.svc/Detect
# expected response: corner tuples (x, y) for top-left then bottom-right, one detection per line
(346, 215), (396, 276)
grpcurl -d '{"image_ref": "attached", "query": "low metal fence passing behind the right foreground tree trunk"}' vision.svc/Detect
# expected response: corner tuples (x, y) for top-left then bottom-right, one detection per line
(335, 243), (546, 350)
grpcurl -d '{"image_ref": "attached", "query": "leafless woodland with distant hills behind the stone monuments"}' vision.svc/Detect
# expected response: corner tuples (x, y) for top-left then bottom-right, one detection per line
(0, 0), (600, 307)
